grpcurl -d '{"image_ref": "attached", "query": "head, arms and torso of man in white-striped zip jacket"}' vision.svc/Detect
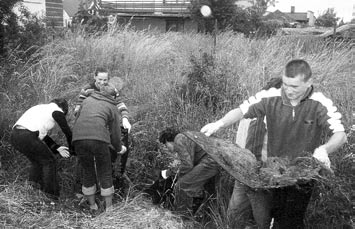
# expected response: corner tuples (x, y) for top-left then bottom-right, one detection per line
(201, 59), (346, 228)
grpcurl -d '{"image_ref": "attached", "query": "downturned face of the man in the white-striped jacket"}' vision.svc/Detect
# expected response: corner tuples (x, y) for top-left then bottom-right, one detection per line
(282, 75), (312, 101)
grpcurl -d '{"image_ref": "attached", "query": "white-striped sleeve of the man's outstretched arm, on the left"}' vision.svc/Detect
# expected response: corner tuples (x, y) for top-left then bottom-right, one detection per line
(239, 88), (281, 118)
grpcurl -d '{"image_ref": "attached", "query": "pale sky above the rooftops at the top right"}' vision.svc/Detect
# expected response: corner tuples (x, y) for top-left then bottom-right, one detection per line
(268, 0), (355, 22)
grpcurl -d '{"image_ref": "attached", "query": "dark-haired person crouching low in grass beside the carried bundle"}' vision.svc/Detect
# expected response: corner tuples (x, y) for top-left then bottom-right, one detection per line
(159, 128), (220, 216)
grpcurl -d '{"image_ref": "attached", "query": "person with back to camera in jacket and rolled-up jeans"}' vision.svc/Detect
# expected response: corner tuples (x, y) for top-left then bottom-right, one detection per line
(73, 85), (125, 210)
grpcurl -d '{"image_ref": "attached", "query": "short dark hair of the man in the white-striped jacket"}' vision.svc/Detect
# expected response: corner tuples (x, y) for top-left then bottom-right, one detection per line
(285, 59), (312, 81)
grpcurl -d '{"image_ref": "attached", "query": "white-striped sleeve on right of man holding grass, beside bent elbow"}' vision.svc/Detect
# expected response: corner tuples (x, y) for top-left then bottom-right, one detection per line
(310, 92), (345, 133)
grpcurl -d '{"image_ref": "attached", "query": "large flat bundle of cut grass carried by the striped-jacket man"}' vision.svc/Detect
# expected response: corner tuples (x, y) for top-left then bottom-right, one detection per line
(184, 131), (331, 189)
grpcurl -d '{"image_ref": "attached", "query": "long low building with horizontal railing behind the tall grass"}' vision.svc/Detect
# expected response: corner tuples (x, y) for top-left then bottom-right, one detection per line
(92, 0), (197, 32)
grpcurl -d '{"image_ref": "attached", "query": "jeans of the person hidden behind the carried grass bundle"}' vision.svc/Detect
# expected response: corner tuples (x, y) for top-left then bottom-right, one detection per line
(227, 181), (272, 228)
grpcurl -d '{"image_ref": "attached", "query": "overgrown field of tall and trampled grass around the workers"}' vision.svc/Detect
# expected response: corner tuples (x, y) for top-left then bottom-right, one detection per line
(0, 29), (354, 228)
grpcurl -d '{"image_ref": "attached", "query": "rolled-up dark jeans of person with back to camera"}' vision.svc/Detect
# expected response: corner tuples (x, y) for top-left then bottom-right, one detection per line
(73, 140), (114, 196)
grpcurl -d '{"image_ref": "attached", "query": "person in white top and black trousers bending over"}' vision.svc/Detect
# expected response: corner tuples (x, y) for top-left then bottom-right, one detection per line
(11, 98), (72, 199)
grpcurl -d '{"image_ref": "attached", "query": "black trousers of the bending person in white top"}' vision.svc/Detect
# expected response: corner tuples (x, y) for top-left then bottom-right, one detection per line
(10, 127), (59, 197)
